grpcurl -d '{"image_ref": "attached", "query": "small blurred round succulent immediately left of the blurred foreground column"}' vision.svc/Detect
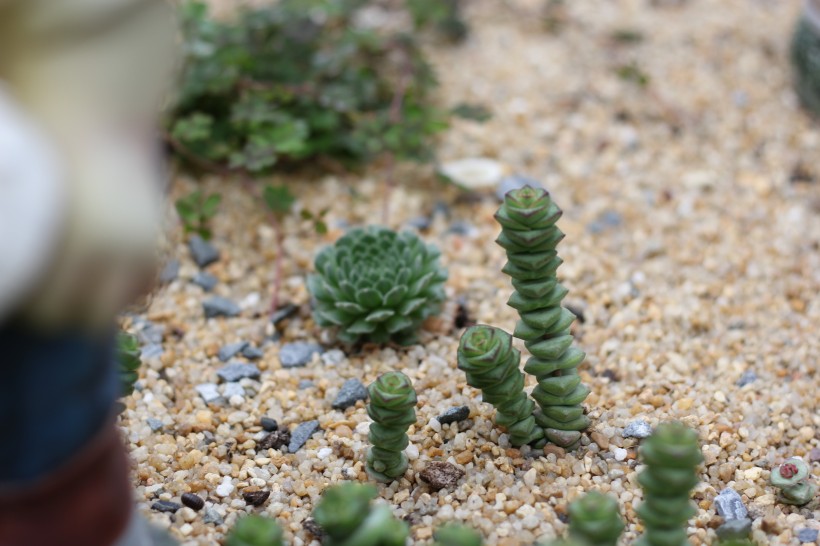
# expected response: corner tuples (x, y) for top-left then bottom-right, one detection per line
(569, 491), (624, 546)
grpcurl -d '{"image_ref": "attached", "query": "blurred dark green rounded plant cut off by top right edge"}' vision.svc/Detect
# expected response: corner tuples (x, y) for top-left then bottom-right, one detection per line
(790, 16), (820, 116)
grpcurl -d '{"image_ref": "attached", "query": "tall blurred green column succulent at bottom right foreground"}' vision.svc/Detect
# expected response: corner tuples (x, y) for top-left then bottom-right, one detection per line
(635, 422), (703, 546)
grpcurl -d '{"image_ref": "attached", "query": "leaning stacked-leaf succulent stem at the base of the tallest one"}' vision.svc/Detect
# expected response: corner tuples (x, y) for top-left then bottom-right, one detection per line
(458, 324), (544, 446)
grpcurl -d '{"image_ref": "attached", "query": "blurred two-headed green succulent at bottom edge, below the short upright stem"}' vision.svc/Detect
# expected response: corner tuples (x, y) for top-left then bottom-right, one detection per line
(313, 483), (409, 546)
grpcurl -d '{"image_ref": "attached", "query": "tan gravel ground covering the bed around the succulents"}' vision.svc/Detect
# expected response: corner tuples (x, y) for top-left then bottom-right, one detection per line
(121, 0), (820, 546)
